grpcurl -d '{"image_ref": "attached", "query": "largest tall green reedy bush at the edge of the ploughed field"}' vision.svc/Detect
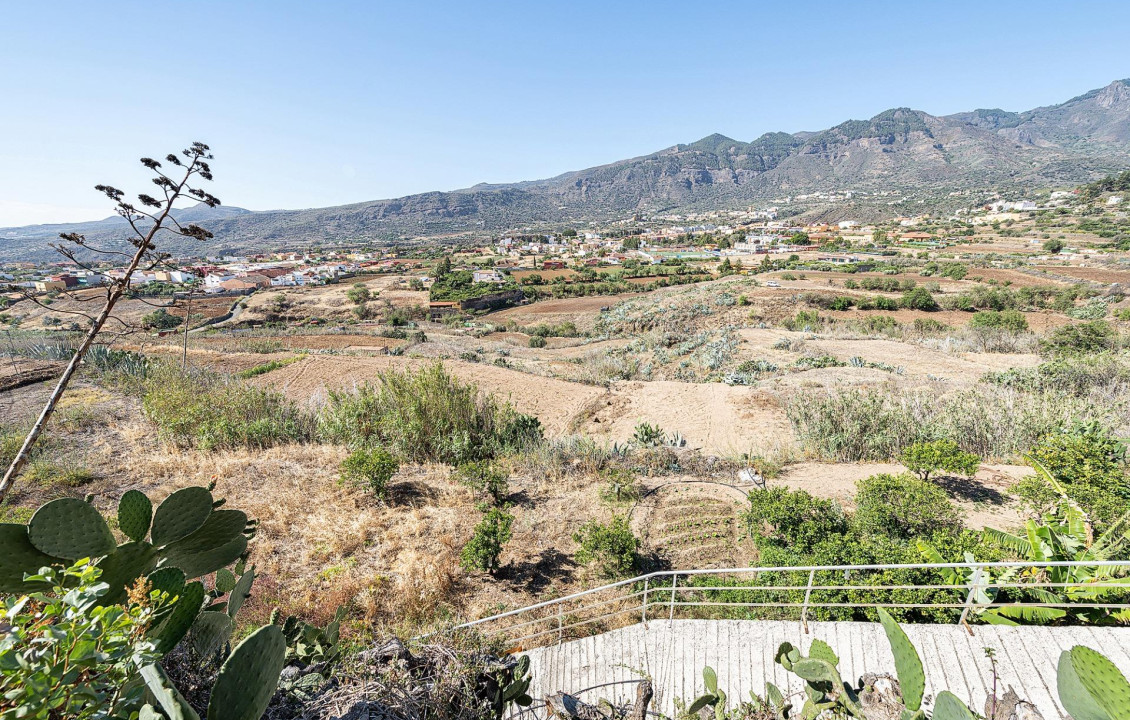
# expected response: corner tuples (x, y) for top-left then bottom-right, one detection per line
(318, 363), (541, 465)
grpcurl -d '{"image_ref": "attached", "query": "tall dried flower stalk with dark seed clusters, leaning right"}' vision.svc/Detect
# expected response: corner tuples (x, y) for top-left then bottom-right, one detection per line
(0, 142), (220, 501)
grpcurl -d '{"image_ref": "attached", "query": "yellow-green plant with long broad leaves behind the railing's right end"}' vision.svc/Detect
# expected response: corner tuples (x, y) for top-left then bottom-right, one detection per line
(919, 458), (1130, 625)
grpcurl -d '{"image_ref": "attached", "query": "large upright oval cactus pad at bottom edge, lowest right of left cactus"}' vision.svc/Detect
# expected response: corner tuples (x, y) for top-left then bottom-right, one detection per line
(208, 625), (286, 720)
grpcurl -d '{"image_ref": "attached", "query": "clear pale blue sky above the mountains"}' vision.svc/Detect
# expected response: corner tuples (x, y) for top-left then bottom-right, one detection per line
(0, 0), (1130, 226)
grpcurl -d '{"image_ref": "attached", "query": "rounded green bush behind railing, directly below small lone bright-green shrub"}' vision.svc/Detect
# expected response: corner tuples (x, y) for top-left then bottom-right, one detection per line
(852, 474), (962, 540)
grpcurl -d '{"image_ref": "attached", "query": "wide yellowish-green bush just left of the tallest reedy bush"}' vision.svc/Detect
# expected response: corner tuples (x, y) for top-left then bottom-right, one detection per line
(141, 365), (312, 450)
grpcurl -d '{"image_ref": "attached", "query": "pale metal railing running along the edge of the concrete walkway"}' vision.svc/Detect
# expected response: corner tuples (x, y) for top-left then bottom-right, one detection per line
(426, 559), (1130, 650)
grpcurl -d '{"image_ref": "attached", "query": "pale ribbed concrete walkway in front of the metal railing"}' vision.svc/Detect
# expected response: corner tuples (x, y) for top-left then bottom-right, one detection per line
(528, 619), (1130, 720)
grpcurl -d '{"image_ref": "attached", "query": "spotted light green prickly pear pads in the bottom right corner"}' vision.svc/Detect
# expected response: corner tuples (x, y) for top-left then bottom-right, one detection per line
(1057, 645), (1130, 720)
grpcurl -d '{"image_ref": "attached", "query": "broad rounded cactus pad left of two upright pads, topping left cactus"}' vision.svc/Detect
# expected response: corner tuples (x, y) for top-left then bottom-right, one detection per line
(27, 497), (118, 561)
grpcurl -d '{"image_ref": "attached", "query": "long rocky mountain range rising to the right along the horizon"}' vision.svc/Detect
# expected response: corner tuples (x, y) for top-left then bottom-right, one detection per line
(0, 80), (1130, 260)
